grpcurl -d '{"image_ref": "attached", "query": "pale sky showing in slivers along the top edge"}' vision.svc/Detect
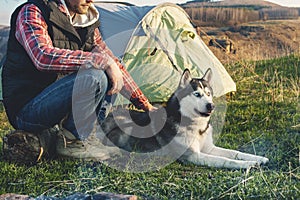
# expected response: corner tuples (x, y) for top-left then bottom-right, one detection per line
(0, 0), (300, 25)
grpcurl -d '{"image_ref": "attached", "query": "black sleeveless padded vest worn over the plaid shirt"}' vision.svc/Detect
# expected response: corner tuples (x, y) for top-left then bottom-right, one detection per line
(2, 0), (100, 128)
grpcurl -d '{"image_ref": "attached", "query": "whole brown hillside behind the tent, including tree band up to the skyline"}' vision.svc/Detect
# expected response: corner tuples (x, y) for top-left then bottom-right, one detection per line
(181, 0), (300, 63)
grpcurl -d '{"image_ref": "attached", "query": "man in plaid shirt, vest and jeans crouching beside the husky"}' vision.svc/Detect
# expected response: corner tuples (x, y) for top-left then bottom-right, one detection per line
(2, 0), (156, 159)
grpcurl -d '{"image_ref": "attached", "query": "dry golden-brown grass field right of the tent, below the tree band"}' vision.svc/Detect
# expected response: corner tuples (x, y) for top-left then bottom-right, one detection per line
(201, 19), (300, 63)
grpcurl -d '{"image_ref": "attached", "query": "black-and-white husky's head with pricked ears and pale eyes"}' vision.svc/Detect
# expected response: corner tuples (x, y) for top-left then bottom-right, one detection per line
(176, 69), (215, 119)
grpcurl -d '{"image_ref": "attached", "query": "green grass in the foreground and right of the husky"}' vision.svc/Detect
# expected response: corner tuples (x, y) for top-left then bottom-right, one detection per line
(0, 56), (300, 199)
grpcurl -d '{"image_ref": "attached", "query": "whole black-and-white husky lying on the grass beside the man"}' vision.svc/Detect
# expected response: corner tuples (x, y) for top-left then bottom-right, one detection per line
(102, 69), (269, 169)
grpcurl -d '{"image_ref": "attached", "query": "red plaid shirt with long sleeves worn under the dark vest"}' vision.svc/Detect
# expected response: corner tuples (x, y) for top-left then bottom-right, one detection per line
(16, 1), (149, 110)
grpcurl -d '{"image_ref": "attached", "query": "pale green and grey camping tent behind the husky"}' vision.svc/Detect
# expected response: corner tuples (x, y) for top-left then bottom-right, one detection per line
(96, 3), (236, 104)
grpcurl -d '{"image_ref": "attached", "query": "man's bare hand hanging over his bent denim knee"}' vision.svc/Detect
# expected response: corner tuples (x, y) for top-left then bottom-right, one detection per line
(105, 63), (124, 95)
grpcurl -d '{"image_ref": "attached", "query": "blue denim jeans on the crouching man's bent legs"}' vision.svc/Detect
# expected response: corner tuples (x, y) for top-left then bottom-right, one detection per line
(16, 69), (108, 140)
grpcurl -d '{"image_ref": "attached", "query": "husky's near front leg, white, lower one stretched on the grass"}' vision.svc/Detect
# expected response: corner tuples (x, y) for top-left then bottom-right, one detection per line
(184, 152), (257, 169)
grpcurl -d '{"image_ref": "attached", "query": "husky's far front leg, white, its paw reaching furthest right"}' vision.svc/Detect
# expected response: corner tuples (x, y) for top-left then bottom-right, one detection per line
(202, 145), (269, 164)
